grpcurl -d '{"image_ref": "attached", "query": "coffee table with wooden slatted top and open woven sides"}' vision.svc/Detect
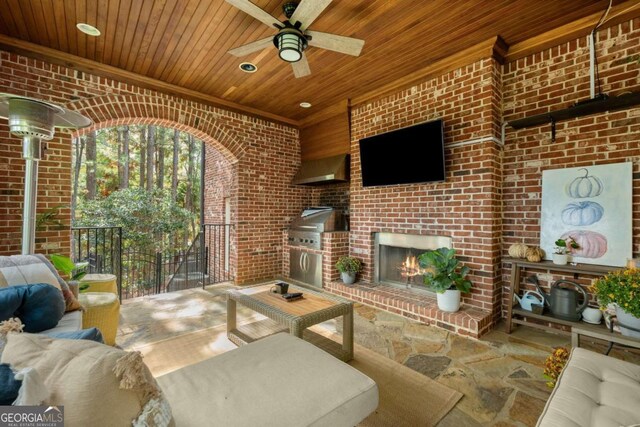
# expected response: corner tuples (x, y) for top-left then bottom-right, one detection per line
(227, 285), (353, 362)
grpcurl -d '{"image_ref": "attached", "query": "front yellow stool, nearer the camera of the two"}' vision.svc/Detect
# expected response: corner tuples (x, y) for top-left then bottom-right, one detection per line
(78, 292), (120, 345)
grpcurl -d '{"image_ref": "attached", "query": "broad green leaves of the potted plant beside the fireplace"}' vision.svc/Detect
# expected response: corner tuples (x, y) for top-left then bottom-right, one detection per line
(418, 248), (471, 294)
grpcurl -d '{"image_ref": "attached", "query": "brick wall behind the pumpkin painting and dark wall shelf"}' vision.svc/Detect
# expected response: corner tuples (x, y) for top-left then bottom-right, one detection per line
(503, 19), (640, 310)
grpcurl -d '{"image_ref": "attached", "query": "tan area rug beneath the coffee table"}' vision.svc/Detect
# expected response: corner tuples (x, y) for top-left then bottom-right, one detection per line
(128, 325), (462, 427)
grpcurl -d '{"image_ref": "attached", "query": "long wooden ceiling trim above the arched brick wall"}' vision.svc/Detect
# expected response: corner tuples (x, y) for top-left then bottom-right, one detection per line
(0, 34), (300, 128)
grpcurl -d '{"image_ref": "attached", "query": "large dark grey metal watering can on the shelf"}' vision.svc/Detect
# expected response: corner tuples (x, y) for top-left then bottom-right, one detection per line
(527, 276), (589, 322)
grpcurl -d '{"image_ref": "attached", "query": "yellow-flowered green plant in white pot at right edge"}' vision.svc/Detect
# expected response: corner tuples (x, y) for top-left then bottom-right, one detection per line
(591, 268), (640, 318)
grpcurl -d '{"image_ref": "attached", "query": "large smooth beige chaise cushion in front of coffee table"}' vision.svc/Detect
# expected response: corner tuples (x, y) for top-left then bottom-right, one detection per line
(158, 334), (378, 427)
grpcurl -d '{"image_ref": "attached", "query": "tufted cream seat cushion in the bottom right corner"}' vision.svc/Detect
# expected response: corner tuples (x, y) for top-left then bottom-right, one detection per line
(538, 348), (640, 427)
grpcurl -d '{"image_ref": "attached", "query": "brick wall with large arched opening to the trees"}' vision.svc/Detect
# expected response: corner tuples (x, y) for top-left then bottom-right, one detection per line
(0, 52), (309, 283)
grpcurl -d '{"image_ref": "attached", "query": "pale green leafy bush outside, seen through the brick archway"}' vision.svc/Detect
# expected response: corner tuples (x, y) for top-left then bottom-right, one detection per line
(76, 188), (196, 251)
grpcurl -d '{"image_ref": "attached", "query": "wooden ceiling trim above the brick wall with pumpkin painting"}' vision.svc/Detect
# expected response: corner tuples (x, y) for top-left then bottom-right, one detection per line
(505, 0), (640, 62)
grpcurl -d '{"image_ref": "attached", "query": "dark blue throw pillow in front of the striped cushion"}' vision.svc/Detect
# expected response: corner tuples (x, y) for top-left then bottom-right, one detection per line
(12, 283), (65, 333)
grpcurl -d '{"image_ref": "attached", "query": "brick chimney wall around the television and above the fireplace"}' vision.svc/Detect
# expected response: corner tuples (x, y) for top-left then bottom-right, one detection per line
(350, 58), (501, 312)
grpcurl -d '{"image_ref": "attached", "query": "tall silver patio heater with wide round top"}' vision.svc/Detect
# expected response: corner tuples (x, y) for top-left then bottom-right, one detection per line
(0, 93), (92, 255)
